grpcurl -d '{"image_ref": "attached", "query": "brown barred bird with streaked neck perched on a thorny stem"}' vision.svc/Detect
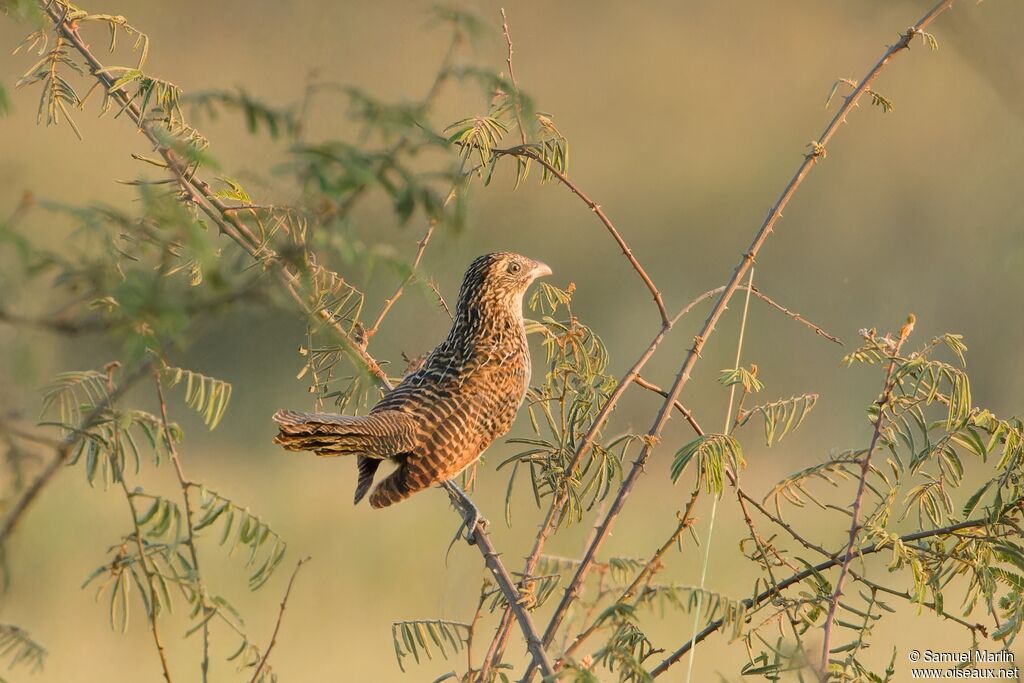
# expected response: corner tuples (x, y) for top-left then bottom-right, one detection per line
(273, 252), (551, 543)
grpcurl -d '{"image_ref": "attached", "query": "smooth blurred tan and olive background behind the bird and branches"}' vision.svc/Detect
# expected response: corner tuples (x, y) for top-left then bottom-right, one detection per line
(0, 0), (1024, 681)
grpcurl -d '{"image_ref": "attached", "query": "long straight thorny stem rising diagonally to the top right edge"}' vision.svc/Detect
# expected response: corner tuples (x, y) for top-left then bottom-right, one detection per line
(527, 0), (954, 678)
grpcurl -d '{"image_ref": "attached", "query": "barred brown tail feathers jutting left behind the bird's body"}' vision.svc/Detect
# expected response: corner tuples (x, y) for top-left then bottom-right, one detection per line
(273, 411), (417, 458)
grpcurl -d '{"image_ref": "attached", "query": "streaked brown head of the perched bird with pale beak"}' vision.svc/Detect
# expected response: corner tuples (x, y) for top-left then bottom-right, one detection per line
(459, 252), (551, 315)
